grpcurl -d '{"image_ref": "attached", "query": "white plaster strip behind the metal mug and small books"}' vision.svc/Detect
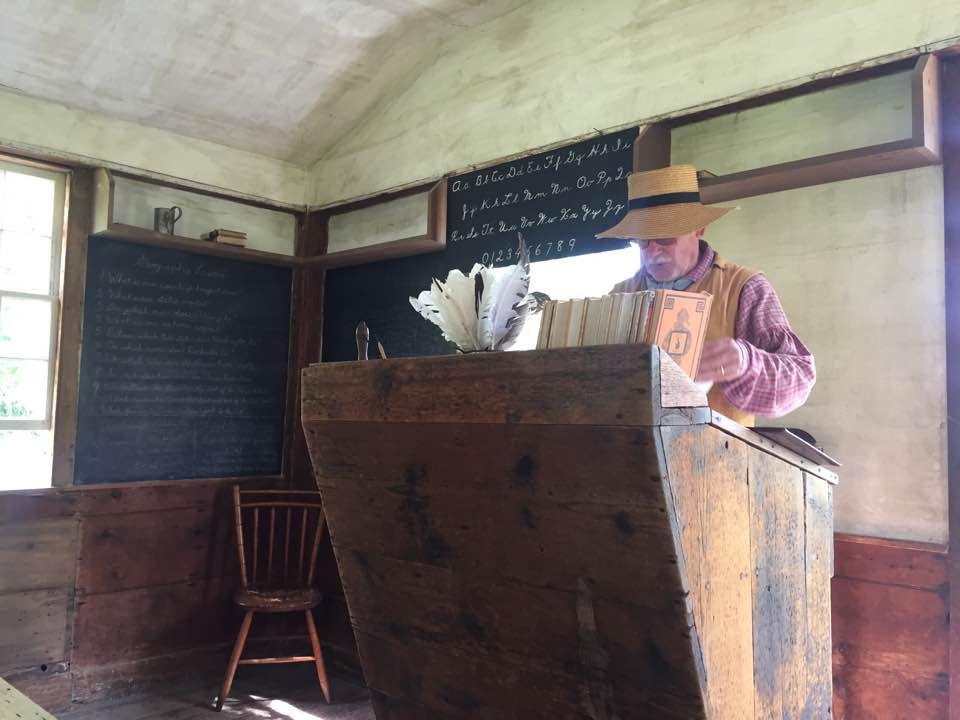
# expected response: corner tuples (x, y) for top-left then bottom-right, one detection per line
(113, 177), (297, 255)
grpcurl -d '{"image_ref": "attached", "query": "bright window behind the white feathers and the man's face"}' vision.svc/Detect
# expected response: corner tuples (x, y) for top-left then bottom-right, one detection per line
(496, 244), (640, 350)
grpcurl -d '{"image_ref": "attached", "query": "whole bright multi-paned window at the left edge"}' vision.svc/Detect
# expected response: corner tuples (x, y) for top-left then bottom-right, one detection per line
(0, 161), (66, 490)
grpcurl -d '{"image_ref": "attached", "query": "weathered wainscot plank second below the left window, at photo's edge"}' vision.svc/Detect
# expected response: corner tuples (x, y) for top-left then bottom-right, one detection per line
(0, 518), (77, 594)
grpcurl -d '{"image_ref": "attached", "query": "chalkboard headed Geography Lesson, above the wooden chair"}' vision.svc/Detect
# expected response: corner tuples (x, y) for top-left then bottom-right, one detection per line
(74, 236), (291, 484)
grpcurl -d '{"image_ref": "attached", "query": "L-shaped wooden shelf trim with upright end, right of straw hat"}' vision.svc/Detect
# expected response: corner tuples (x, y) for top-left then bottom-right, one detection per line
(700, 55), (941, 203)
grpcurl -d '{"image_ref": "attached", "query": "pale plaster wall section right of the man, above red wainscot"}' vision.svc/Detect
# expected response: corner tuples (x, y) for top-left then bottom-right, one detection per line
(707, 167), (947, 543)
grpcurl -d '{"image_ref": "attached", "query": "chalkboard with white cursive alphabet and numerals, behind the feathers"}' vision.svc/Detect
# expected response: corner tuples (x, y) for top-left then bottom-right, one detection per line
(323, 128), (639, 361)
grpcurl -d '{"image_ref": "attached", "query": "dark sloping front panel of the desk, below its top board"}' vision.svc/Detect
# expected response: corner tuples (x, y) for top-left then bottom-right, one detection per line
(309, 422), (702, 717)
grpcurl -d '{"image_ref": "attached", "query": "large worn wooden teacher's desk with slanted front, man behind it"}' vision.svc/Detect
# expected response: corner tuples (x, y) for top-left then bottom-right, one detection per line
(302, 345), (836, 720)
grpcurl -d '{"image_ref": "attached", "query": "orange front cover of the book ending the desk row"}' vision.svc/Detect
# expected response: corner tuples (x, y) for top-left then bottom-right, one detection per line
(653, 290), (713, 380)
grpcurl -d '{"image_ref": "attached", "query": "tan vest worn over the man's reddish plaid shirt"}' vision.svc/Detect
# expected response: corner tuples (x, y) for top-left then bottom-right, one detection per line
(611, 255), (758, 427)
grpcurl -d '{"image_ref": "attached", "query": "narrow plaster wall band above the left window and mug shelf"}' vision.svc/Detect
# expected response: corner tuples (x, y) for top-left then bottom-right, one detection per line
(0, 90), (306, 206)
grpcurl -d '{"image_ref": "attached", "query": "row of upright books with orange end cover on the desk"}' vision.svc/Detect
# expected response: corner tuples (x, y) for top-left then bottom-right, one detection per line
(537, 290), (713, 378)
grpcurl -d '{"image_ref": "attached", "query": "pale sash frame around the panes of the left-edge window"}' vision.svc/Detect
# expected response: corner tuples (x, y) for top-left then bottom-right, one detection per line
(0, 157), (69, 432)
